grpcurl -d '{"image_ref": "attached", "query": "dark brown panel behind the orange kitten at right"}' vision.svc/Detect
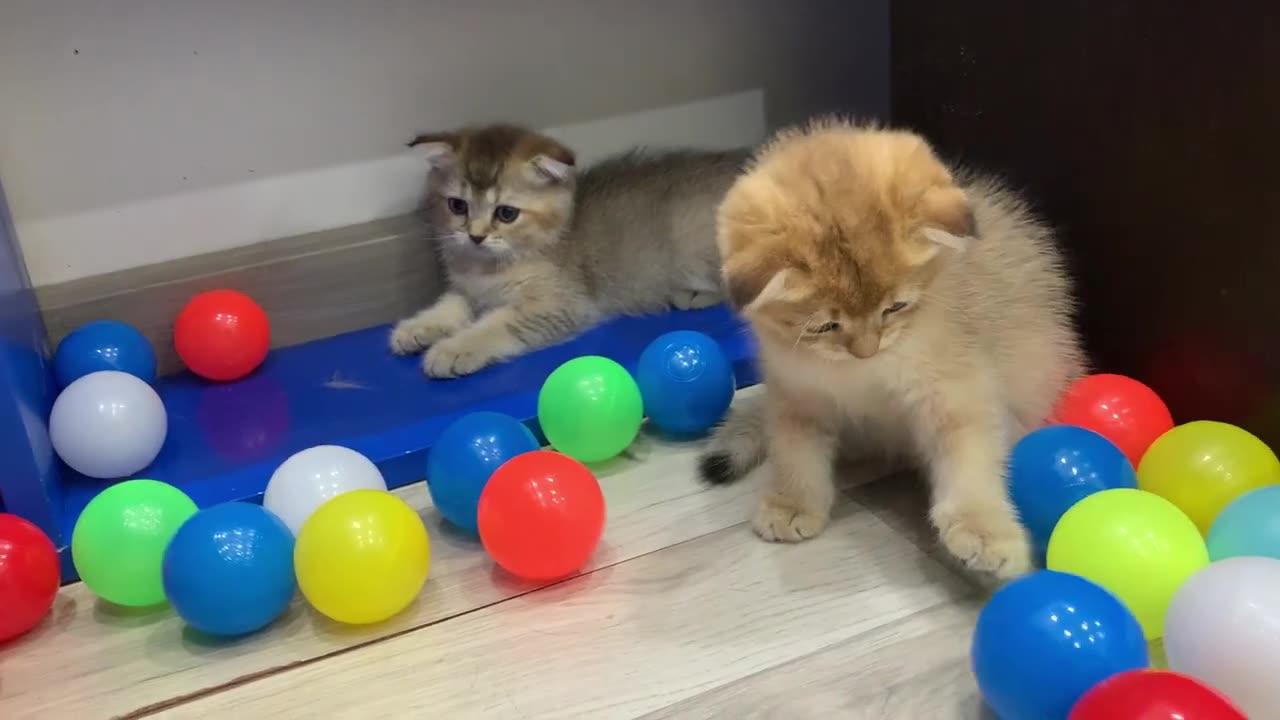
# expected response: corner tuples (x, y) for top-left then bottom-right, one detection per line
(891, 0), (1280, 446)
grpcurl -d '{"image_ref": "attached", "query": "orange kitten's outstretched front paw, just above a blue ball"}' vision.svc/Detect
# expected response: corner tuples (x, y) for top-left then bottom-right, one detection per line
(937, 514), (1032, 580)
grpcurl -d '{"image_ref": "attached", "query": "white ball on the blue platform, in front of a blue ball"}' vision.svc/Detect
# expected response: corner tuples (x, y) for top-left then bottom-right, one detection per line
(49, 370), (169, 479)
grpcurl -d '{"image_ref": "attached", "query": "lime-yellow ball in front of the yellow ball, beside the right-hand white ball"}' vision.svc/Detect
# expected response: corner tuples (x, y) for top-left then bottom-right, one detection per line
(1048, 488), (1208, 639)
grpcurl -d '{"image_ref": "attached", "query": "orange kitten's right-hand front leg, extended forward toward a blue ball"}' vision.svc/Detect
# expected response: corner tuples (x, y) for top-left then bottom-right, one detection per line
(918, 392), (1032, 579)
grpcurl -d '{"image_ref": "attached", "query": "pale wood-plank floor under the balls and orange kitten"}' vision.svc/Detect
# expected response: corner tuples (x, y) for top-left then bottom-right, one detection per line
(0, 389), (984, 720)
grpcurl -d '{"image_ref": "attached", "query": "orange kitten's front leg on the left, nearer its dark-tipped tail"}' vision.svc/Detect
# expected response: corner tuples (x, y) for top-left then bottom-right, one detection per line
(753, 409), (836, 542)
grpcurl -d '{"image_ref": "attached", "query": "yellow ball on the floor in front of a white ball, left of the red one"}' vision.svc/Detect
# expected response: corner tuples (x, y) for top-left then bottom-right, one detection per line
(293, 489), (431, 625)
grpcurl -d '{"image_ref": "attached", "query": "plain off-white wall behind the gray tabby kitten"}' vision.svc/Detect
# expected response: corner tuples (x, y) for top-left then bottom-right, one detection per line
(0, 0), (888, 284)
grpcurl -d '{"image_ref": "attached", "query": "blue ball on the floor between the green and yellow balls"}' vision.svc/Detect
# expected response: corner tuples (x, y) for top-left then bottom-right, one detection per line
(164, 502), (297, 637)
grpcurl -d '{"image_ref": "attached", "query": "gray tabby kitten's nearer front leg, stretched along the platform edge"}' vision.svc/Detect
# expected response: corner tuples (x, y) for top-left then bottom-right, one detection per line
(422, 302), (591, 378)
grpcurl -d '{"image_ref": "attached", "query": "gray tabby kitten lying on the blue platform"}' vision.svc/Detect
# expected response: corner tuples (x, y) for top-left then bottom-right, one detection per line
(390, 126), (748, 378)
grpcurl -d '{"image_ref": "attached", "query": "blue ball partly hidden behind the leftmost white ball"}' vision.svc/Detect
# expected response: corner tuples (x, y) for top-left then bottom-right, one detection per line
(54, 320), (156, 387)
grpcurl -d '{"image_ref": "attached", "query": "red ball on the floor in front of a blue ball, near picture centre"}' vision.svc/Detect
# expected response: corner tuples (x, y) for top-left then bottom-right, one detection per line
(476, 450), (604, 580)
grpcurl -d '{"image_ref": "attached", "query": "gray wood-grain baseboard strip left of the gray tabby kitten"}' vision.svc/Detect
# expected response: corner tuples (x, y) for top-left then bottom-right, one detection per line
(36, 215), (443, 374)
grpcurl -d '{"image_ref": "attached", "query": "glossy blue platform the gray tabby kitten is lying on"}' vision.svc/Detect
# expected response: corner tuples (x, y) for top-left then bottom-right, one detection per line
(0, 288), (758, 579)
